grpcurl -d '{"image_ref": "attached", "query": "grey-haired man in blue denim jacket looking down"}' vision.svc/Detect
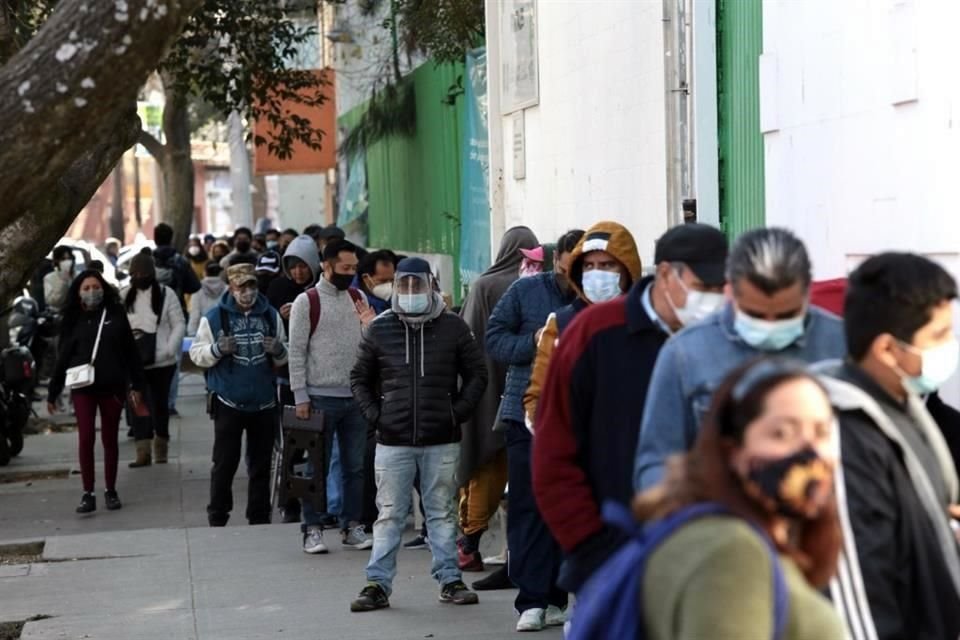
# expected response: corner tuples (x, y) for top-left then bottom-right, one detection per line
(634, 228), (846, 490)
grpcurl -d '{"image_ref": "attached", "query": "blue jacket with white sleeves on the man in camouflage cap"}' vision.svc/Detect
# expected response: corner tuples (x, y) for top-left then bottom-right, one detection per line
(190, 291), (287, 412)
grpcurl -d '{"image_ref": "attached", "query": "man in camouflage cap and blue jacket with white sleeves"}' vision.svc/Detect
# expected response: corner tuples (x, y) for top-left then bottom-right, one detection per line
(190, 264), (287, 527)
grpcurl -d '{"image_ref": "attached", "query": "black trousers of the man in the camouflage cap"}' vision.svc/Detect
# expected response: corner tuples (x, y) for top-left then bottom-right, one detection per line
(207, 402), (277, 527)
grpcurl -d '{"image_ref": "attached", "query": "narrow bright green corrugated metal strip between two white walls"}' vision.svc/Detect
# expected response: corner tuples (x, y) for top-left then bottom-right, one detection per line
(717, 0), (764, 239)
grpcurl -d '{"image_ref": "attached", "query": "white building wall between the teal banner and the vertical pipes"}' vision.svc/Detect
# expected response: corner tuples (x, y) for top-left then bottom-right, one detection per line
(487, 0), (667, 264)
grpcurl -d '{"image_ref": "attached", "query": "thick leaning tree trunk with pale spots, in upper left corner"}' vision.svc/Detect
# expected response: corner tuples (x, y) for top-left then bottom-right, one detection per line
(0, 0), (202, 230)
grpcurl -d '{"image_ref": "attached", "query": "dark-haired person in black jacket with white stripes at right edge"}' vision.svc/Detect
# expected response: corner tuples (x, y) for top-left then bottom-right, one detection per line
(821, 253), (960, 640)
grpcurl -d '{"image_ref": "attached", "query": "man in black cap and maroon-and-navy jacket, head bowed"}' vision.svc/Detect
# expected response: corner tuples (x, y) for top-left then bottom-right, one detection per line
(528, 224), (727, 591)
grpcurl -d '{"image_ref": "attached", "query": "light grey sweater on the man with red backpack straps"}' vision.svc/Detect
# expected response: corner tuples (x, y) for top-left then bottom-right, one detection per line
(290, 278), (366, 404)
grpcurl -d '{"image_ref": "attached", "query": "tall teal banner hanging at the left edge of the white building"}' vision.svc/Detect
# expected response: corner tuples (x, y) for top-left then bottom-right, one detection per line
(460, 47), (490, 284)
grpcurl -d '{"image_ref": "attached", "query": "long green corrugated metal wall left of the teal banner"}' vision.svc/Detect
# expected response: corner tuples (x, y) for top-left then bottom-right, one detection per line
(340, 62), (465, 296)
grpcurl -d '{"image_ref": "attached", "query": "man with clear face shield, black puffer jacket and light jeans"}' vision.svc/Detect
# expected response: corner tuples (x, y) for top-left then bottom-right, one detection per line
(350, 258), (487, 611)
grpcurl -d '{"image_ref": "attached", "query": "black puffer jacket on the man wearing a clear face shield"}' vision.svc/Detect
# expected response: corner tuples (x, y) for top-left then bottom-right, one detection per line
(350, 297), (487, 447)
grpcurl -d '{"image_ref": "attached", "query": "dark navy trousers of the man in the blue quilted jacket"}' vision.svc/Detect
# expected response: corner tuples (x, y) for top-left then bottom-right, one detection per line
(506, 421), (567, 613)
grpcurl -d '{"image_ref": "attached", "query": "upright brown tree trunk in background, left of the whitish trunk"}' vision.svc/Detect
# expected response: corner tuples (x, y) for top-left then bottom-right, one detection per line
(160, 78), (194, 251)
